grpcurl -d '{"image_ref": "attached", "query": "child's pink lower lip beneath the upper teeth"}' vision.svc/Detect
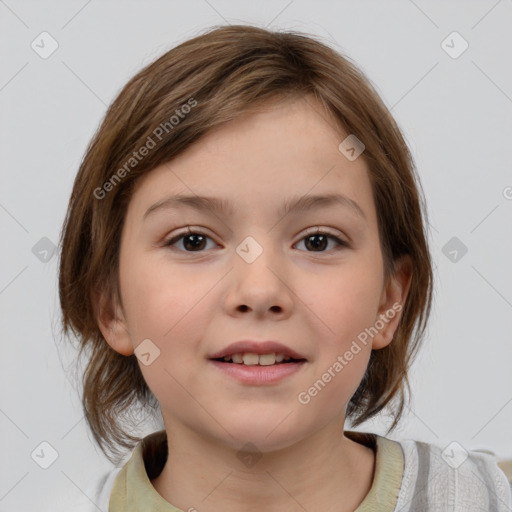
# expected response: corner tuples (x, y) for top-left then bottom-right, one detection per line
(210, 359), (306, 386)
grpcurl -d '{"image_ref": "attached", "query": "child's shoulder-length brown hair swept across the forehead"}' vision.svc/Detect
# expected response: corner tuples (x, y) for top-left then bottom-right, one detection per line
(59, 25), (433, 460)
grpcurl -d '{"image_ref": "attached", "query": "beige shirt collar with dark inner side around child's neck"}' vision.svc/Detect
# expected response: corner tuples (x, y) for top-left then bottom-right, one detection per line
(109, 430), (404, 512)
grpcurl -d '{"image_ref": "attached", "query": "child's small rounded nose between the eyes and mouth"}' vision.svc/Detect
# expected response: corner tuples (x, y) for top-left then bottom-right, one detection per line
(225, 237), (294, 319)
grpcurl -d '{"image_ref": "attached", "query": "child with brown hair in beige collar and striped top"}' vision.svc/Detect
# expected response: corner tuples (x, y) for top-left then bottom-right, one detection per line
(59, 22), (512, 512)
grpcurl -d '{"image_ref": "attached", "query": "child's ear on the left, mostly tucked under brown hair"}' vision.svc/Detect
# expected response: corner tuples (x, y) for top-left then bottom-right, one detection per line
(93, 287), (134, 356)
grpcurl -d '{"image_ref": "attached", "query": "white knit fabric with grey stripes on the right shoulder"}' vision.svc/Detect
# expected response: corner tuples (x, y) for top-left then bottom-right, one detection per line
(390, 440), (512, 512)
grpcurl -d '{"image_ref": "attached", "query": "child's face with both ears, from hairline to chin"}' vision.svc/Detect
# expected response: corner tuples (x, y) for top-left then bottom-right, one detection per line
(101, 98), (412, 452)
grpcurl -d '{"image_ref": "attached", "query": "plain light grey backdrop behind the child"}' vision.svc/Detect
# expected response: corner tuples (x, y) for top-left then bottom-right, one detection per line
(0, 0), (512, 512)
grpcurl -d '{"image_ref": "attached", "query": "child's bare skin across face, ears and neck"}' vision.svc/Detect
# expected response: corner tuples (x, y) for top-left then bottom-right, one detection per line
(98, 97), (411, 512)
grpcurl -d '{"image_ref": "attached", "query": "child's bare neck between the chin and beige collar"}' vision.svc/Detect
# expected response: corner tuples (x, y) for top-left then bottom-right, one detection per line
(152, 422), (375, 512)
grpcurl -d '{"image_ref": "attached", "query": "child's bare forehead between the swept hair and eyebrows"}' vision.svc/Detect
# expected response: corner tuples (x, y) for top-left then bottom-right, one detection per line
(130, 97), (373, 226)
